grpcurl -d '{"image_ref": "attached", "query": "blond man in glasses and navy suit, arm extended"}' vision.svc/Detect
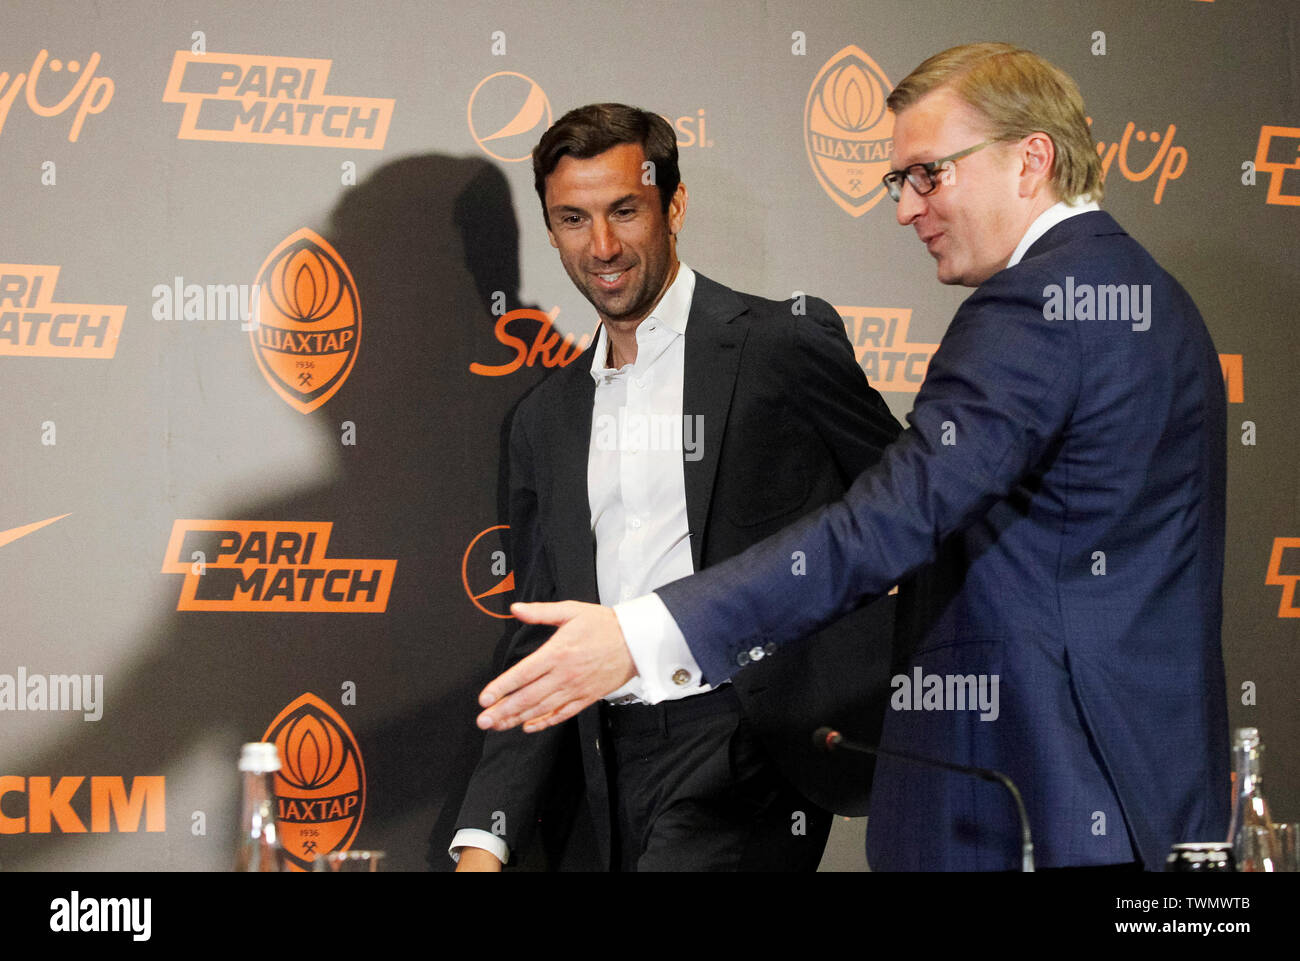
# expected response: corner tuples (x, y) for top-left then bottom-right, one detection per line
(480, 44), (1229, 870)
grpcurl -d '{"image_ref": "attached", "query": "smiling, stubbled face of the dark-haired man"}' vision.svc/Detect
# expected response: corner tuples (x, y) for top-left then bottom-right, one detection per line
(546, 143), (686, 328)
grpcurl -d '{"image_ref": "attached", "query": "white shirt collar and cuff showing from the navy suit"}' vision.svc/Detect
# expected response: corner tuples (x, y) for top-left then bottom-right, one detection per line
(613, 200), (1101, 704)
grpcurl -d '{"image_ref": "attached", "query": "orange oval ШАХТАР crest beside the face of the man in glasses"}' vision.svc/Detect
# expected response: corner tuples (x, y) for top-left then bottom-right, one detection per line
(803, 44), (893, 217)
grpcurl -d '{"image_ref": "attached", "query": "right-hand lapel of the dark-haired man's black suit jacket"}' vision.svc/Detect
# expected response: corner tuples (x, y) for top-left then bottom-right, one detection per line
(686, 272), (749, 571)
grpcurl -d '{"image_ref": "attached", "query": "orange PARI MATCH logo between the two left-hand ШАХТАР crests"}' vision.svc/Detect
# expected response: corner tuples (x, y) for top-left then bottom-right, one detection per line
(163, 520), (398, 614)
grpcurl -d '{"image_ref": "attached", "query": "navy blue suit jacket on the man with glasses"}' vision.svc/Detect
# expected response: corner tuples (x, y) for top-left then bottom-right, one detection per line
(658, 212), (1229, 870)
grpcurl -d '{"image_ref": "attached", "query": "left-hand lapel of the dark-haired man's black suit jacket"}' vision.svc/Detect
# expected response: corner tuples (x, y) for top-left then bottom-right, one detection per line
(550, 350), (599, 603)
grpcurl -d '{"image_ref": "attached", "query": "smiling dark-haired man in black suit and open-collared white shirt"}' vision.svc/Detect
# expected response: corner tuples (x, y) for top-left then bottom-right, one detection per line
(451, 104), (900, 870)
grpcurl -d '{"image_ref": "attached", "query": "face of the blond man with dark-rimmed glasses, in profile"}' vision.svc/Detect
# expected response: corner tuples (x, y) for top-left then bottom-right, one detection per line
(893, 87), (1054, 287)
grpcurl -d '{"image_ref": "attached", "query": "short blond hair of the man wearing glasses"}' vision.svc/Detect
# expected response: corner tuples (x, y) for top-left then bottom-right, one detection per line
(887, 43), (1102, 202)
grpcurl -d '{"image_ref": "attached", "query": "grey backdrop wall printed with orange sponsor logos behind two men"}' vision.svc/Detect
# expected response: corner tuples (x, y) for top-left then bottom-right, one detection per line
(0, 0), (1300, 870)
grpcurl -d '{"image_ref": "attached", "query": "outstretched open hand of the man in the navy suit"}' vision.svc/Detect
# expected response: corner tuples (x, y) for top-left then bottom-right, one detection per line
(477, 601), (637, 733)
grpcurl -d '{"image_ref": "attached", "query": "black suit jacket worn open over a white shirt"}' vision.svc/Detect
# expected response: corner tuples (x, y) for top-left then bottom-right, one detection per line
(456, 273), (901, 866)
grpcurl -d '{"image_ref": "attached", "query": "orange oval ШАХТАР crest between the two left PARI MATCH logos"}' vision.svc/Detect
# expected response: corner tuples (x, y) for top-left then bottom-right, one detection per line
(248, 228), (361, 414)
